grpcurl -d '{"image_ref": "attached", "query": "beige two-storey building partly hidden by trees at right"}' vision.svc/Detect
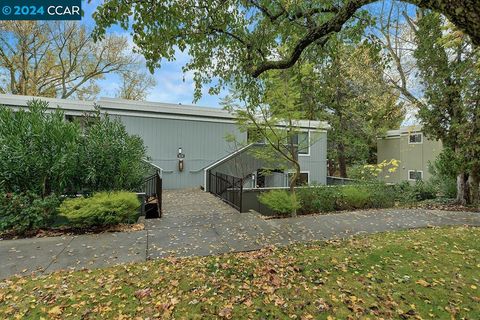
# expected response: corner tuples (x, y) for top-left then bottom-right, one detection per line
(377, 125), (442, 183)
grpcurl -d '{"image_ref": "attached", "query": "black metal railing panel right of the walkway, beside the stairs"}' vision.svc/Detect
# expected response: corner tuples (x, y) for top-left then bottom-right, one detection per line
(208, 171), (247, 212)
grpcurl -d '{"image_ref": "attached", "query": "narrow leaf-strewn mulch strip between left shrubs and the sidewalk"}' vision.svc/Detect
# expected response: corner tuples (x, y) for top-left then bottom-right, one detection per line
(0, 223), (145, 240)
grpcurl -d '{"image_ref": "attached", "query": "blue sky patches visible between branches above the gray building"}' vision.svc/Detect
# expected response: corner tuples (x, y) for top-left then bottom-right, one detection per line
(81, 0), (227, 108)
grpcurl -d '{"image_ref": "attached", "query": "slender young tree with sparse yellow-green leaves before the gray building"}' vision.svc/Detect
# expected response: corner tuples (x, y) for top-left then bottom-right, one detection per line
(223, 70), (315, 216)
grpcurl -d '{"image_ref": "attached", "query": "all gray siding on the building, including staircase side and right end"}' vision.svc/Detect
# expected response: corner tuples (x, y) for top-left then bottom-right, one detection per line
(117, 115), (327, 189)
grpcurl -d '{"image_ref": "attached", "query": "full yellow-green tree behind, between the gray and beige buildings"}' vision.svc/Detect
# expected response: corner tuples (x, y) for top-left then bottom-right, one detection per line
(309, 39), (404, 177)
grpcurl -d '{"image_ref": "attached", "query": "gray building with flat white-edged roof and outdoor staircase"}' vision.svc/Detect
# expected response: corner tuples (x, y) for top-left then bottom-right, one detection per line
(0, 95), (328, 189)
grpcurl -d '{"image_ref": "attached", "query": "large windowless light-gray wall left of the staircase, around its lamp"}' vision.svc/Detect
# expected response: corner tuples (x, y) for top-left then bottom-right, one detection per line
(118, 116), (246, 189)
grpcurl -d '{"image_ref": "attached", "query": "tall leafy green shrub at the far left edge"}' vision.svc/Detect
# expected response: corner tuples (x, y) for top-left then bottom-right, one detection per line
(0, 100), (80, 195)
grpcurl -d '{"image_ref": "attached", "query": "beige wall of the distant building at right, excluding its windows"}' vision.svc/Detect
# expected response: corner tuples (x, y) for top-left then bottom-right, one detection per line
(377, 133), (442, 183)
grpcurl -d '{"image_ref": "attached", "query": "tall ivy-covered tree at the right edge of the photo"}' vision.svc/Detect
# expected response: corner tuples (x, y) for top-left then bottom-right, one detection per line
(414, 12), (480, 204)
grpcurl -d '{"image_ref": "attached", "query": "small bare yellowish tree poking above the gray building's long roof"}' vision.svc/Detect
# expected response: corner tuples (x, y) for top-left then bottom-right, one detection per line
(117, 71), (157, 100)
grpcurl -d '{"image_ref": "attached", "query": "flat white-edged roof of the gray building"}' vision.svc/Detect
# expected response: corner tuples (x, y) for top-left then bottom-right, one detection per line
(0, 94), (330, 129)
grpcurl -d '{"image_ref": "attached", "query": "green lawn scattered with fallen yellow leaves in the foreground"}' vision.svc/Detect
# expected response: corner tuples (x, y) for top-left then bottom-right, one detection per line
(0, 227), (480, 319)
